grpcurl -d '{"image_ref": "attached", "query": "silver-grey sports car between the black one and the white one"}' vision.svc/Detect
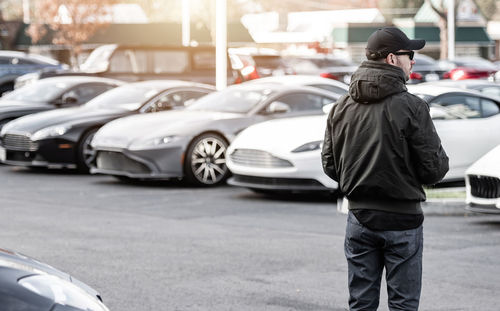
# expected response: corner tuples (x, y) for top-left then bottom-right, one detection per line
(91, 83), (340, 186)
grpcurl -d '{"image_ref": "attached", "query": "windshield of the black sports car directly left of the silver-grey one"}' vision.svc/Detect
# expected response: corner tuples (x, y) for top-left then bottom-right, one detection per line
(85, 84), (160, 111)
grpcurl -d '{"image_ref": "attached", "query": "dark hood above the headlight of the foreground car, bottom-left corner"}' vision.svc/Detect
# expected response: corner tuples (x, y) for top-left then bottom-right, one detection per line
(0, 248), (99, 297)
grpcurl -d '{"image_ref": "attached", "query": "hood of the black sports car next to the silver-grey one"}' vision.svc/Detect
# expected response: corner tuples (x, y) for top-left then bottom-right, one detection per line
(4, 107), (125, 133)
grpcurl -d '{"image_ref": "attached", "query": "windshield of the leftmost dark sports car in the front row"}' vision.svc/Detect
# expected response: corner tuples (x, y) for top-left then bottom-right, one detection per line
(2, 80), (71, 103)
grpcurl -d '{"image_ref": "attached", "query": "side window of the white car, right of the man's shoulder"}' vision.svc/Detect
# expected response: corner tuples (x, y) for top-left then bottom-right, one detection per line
(430, 95), (482, 120)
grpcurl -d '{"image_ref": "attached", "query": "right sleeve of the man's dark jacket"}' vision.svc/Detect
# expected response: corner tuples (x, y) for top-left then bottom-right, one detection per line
(409, 102), (449, 185)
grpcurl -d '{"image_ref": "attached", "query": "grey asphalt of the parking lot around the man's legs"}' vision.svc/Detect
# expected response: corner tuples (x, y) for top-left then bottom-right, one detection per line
(0, 166), (500, 311)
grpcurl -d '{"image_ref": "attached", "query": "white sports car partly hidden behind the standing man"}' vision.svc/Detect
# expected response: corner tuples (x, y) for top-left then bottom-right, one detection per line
(227, 85), (500, 192)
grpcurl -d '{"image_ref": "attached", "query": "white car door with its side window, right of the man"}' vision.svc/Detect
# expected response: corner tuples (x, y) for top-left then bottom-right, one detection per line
(430, 94), (500, 180)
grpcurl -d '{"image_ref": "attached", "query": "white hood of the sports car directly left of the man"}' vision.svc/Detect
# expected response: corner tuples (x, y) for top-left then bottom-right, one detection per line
(231, 115), (327, 153)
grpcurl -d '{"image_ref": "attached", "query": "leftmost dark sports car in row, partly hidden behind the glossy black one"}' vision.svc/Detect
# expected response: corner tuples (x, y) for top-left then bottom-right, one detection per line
(0, 76), (124, 128)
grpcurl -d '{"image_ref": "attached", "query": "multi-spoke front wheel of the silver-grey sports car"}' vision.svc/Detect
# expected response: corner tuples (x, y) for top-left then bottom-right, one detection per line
(184, 133), (229, 186)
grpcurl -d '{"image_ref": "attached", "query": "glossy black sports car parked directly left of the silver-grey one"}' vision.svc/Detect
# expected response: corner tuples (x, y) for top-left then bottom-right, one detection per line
(0, 80), (214, 171)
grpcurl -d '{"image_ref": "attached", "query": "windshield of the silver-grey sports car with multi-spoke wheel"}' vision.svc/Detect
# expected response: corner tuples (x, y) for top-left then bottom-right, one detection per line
(187, 88), (271, 113)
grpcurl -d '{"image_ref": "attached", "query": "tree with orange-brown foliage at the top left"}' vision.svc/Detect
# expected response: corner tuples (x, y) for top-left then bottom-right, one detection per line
(26, 0), (115, 66)
